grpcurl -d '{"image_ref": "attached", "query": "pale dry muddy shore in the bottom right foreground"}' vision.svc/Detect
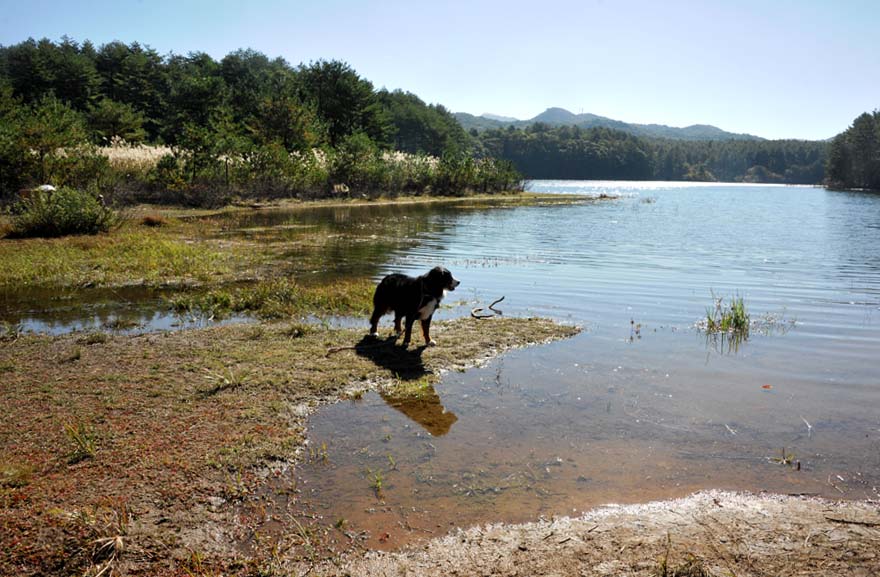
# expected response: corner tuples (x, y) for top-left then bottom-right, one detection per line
(328, 491), (880, 577)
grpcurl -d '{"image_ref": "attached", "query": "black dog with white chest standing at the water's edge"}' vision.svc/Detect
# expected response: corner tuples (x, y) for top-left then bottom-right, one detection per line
(370, 266), (459, 347)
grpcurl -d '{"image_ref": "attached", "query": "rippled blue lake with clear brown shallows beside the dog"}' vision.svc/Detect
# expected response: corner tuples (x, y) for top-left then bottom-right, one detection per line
(290, 181), (880, 548)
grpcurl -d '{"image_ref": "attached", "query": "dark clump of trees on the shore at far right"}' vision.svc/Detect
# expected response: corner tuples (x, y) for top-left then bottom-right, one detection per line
(828, 110), (880, 190)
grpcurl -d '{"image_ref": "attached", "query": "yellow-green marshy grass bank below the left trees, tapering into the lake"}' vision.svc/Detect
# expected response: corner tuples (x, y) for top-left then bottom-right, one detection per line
(0, 193), (582, 290)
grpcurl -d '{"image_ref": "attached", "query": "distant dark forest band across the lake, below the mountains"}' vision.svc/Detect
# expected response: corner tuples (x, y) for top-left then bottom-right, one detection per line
(471, 123), (827, 184)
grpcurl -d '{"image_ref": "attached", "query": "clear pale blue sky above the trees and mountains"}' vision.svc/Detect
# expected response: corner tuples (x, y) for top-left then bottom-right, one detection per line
(0, 0), (880, 139)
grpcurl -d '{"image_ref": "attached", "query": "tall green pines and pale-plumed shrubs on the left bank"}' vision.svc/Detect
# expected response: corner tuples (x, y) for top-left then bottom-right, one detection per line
(0, 37), (519, 200)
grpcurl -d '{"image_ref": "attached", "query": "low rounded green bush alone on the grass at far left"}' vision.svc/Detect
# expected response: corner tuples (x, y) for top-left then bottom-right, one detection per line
(10, 188), (119, 237)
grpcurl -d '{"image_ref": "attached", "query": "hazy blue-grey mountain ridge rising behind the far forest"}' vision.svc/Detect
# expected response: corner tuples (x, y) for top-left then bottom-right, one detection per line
(455, 108), (764, 140)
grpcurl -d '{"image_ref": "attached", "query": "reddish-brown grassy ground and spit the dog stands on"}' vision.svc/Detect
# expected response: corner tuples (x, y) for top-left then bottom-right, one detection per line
(0, 318), (577, 575)
